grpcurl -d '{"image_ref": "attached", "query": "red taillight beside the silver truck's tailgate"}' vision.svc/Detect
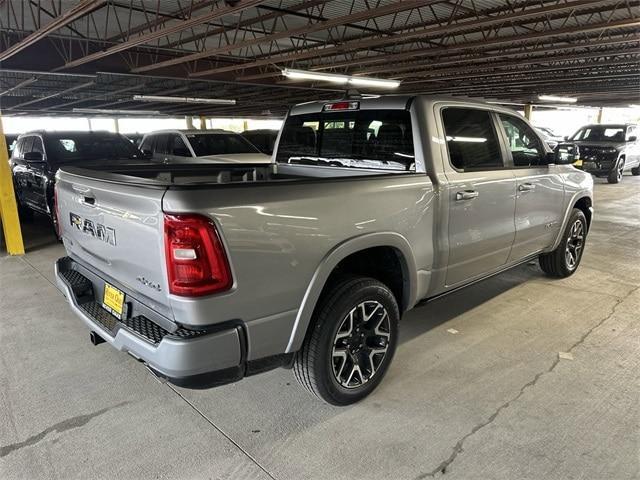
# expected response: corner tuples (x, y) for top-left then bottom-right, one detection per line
(164, 214), (233, 297)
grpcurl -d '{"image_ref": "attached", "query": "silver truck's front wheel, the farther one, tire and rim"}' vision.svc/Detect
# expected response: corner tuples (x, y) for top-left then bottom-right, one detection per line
(538, 208), (588, 278)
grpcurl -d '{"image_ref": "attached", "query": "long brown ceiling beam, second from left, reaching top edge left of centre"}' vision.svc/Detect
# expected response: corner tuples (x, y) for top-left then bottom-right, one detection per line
(53, 0), (264, 72)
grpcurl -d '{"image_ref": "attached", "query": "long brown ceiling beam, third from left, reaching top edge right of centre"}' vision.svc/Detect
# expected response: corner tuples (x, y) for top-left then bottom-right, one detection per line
(131, 0), (430, 73)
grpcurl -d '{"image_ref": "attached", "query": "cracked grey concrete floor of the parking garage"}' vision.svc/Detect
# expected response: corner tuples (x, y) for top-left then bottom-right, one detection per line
(0, 176), (640, 480)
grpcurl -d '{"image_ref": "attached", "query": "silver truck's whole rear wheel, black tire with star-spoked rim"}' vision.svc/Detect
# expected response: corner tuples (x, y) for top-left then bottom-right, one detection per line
(293, 277), (400, 406)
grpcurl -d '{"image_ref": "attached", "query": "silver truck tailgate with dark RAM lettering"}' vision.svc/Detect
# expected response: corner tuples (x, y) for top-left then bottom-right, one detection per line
(56, 170), (173, 318)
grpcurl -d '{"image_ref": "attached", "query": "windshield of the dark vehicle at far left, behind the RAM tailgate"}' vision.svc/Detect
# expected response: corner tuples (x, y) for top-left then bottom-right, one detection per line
(46, 132), (142, 163)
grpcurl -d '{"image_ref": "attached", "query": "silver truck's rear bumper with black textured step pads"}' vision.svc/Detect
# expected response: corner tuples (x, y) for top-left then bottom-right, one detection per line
(55, 257), (245, 388)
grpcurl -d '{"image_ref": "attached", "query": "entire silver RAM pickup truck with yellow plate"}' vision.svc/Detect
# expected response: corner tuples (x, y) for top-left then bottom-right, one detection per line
(56, 96), (593, 405)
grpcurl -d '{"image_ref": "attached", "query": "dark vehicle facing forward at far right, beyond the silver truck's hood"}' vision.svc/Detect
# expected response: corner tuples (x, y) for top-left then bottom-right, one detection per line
(570, 124), (640, 183)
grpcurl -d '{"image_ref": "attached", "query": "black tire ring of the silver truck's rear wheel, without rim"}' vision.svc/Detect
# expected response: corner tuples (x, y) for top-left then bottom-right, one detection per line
(314, 280), (400, 405)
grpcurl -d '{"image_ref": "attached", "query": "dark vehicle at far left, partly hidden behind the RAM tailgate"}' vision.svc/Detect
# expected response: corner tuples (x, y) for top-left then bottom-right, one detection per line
(9, 131), (148, 232)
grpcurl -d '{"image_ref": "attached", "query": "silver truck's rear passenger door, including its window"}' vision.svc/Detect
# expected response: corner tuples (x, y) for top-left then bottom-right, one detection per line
(440, 106), (516, 287)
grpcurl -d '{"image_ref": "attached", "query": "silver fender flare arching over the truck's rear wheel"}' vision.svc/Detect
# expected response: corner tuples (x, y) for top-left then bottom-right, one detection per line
(286, 232), (418, 353)
